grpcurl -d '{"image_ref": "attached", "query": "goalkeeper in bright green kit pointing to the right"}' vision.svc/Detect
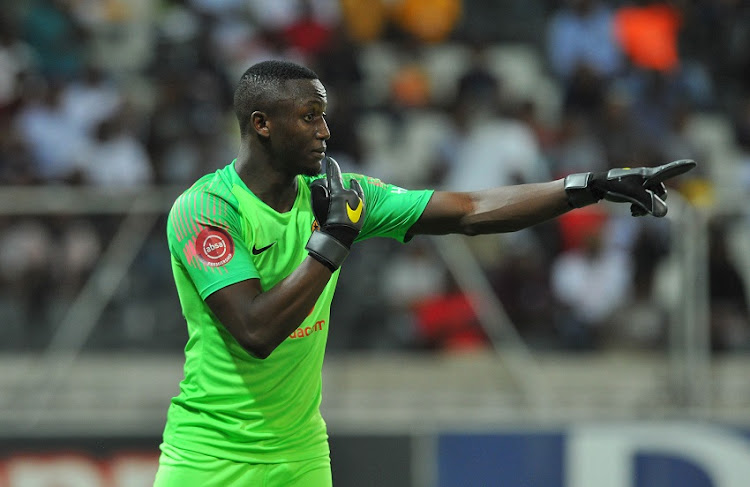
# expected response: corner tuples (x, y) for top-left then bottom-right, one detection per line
(155, 61), (695, 487)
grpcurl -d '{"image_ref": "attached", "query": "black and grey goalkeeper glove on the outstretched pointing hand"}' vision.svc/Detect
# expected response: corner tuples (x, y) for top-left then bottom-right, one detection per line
(565, 159), (696, 217)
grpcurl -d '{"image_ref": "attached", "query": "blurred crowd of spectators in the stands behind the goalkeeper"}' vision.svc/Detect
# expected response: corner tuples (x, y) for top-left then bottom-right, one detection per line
(0, 0), (750, 351)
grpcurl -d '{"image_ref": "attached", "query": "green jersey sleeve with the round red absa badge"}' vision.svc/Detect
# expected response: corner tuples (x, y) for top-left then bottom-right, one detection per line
(167, 191), (259, 299)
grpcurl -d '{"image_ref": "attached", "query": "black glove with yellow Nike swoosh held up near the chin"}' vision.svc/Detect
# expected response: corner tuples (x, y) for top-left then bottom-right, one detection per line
(305, 157), (365, 272)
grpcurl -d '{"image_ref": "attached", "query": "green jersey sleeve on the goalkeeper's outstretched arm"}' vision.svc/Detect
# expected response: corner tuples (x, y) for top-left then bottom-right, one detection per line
(352, 174), (434, 242)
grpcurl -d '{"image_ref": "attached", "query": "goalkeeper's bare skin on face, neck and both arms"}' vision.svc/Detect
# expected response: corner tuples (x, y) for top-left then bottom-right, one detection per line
(206, 80), (570, 359)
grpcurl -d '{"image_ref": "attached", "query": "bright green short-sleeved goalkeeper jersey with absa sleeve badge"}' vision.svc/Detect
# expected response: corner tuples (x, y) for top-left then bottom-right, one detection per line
(164, 163), (432, 463)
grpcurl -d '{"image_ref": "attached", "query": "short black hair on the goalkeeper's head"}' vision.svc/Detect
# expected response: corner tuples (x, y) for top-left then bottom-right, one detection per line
(234, 60), (318, 136)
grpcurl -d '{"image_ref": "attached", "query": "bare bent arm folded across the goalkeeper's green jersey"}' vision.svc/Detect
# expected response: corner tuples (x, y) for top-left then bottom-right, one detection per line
(205, 256), (331, 359)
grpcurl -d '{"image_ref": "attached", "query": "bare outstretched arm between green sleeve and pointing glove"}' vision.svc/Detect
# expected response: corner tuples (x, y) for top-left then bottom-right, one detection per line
(409, 179), (571, 236)
